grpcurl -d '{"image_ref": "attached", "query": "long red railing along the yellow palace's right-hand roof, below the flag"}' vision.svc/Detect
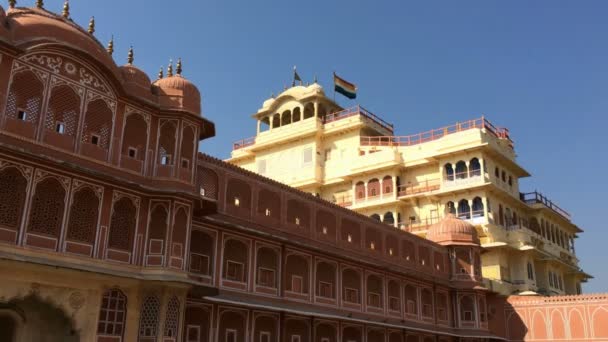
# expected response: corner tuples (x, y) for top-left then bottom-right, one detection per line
(360, 117), (513, 147)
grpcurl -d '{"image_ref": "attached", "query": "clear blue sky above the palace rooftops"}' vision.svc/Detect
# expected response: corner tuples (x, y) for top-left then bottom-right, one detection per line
(57, 0), (608, 292)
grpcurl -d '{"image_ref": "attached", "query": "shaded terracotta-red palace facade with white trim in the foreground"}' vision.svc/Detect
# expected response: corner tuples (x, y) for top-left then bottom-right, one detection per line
(0, 1), (608, 342)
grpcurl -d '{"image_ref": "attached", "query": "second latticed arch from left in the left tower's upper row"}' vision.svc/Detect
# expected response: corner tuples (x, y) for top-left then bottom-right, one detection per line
(44, 85), (80, 150)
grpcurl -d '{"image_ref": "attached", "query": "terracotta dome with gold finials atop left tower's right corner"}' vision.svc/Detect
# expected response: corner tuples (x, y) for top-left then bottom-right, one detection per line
(154, 75), (201, 115)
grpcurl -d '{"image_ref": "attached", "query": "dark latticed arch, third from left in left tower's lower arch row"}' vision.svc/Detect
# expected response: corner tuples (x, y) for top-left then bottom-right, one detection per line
(67, 187), (99, 244)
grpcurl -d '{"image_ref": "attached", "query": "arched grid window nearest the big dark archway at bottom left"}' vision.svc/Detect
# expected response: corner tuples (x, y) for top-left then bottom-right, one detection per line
(97, 289), (127, 338)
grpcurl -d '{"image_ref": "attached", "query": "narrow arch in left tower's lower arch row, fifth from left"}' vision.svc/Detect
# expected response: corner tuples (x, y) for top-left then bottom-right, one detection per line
(146, 204), (169, 266)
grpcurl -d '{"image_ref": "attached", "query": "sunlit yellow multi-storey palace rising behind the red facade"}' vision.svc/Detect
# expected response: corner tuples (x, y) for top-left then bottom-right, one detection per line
(228, 82), (590, 295)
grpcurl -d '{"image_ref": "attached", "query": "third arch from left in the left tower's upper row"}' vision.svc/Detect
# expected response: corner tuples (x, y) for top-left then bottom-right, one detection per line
(80, 99), (114, 160)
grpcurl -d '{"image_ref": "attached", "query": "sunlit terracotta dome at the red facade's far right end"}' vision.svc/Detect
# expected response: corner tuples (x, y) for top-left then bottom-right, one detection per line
(426, 214), (480, 246)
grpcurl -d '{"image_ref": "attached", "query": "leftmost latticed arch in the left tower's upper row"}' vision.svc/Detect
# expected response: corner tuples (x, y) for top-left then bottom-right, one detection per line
(4, 70), (44, 139)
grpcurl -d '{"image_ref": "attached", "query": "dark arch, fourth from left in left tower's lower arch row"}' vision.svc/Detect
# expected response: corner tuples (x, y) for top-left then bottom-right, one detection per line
(108, 197), (137, 251)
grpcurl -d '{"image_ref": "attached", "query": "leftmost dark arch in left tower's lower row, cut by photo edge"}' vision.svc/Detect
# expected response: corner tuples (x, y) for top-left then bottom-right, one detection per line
(0, 167), (27, 234)
